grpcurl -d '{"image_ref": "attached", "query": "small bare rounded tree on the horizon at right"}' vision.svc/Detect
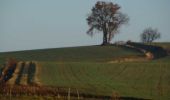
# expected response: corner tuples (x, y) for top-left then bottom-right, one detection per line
(141, 27), (161, 43)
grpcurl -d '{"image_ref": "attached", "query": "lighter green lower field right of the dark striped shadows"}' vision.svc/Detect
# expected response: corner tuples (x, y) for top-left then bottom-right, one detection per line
(40, 62), (170, 100)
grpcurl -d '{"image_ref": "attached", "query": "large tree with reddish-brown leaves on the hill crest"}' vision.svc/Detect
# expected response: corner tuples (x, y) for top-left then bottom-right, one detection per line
(86, 1), (129, 45)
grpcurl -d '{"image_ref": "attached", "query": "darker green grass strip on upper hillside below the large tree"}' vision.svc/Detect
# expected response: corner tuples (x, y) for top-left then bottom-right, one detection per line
(0, 46), (143, 64)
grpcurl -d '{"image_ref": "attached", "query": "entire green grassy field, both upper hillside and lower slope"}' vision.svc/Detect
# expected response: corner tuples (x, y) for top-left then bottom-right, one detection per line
(0, 44), (170, 100)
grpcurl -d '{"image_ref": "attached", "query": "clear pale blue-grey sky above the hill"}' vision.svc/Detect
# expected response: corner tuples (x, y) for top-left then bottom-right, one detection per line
(0, 0), (170, 52)
